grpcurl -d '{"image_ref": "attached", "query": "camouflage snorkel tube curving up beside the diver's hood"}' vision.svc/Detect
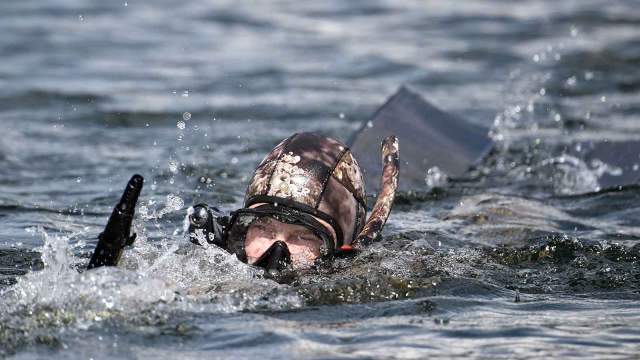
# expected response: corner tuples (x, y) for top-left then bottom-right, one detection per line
(353, 135), (400, 249)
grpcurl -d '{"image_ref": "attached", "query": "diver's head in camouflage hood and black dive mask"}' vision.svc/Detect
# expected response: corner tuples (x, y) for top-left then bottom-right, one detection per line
(227, 133), (366, 268)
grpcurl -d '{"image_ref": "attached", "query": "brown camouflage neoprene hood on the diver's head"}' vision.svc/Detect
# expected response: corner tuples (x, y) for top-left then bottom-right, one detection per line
(244, 133), (367, 247)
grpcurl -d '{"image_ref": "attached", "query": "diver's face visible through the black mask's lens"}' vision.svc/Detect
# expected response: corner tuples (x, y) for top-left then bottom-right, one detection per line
(244, 217), (322, 268)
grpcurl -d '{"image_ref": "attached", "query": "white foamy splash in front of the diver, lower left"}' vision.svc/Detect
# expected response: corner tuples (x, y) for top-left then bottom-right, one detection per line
(0, 211), (303, 355)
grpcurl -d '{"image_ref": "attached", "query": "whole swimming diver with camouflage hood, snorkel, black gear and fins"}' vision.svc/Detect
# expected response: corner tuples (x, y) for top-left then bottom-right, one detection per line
(88, 86), (640, 274)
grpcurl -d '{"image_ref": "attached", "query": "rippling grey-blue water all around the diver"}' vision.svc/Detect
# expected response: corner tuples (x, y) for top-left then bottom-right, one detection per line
(0, 0), (640, 359)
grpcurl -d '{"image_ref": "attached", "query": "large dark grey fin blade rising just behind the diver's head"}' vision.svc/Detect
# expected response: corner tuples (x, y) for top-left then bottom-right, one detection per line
(348, 87), (492, 193)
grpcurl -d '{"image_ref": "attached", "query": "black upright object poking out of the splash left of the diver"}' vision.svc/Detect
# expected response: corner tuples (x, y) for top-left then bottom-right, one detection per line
(87, 175), (144, 269)
